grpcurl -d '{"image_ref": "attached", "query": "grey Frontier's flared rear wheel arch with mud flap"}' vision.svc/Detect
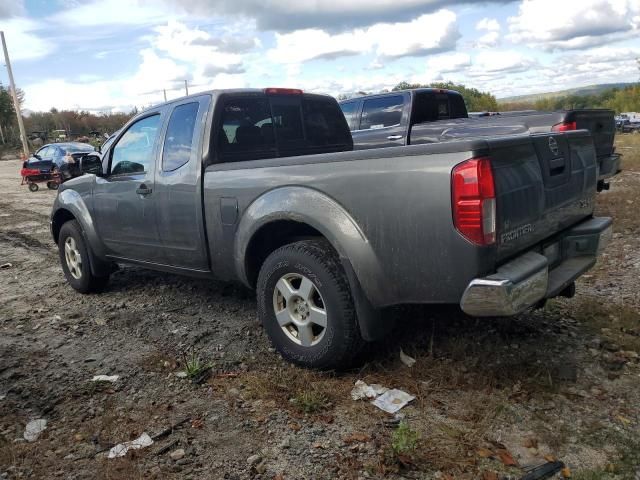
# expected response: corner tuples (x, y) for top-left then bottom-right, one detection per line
(234, 186), (393, 341)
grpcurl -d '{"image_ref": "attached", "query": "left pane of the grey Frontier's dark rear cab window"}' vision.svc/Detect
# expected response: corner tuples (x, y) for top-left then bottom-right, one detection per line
(216, 97), (276, 162)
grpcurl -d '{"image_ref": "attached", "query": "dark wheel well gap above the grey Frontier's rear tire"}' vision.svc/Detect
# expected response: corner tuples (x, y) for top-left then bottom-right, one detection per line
(245, 220), (323, 287)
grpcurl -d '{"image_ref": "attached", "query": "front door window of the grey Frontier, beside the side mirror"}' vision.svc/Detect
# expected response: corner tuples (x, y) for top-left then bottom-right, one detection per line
(111, 114), (160, 175)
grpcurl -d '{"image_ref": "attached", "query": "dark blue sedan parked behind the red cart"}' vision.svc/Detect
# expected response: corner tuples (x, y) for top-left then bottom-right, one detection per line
(23, 142), (95, 181)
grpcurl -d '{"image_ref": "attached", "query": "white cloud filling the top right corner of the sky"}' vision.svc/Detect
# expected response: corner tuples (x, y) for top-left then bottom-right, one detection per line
(507, 0), (640, 50)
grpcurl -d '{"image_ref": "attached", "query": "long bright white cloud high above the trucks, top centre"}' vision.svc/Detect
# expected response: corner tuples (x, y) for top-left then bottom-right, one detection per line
(267, 10), (460, 64)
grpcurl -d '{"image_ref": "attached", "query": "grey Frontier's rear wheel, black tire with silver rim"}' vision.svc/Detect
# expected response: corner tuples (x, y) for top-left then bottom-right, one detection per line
(257, 240), (364, 369)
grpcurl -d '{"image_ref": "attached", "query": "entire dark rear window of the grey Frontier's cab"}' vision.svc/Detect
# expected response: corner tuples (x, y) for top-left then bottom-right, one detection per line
(214, 94), (353, 162)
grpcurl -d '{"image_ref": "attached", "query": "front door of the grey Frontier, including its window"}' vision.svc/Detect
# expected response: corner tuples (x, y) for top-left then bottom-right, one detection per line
(94, 111), (163, 263)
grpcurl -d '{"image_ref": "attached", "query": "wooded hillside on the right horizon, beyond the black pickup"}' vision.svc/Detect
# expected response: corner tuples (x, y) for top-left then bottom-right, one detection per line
(498, 85), (640, 113)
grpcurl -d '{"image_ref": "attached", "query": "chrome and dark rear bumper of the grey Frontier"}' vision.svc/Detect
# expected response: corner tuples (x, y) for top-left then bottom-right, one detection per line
(460, 217), (613, 317)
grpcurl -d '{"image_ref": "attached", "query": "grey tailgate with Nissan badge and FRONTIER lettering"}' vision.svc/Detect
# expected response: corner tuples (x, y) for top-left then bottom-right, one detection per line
(489, 131), (597, 260)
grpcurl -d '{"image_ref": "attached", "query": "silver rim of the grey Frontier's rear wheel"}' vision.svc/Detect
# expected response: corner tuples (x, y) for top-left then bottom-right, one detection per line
(273, 273), (327, 347)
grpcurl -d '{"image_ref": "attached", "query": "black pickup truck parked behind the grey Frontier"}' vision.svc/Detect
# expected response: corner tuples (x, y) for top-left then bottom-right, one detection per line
(340, 88), (620, 191)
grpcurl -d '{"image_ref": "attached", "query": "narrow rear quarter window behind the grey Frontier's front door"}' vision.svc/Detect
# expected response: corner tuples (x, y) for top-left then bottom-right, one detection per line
(162, 102), (200, 172)
